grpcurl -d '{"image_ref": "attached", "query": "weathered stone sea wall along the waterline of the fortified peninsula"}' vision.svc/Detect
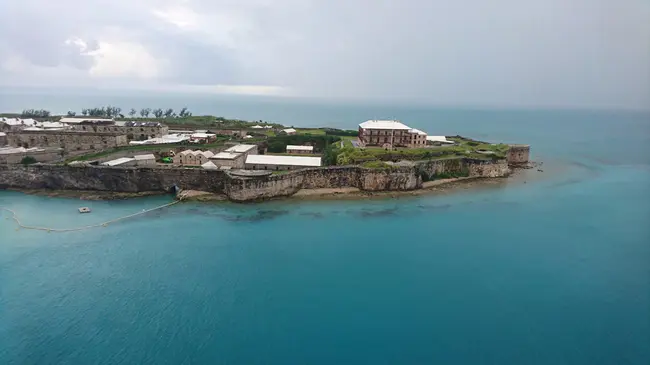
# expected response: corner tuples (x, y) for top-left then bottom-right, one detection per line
(0, 159), (510, 202)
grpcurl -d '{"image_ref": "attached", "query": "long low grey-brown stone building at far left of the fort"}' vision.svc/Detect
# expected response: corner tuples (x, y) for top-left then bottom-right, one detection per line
(7, 130), (128, 151)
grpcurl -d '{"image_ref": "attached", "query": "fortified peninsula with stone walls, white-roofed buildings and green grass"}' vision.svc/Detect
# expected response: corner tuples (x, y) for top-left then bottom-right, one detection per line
(0, 106), (530, 202)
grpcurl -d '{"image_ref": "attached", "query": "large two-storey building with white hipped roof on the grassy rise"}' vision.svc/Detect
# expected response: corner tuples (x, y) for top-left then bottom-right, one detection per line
(359, 120), (427, 148)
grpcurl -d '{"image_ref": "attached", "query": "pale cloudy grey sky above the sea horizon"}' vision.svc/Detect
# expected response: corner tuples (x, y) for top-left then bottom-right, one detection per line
(0, 0), (650, 109)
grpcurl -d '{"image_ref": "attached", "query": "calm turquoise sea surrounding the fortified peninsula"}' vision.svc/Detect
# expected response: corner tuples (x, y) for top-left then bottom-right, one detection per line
(0, 97), (650, 365)
